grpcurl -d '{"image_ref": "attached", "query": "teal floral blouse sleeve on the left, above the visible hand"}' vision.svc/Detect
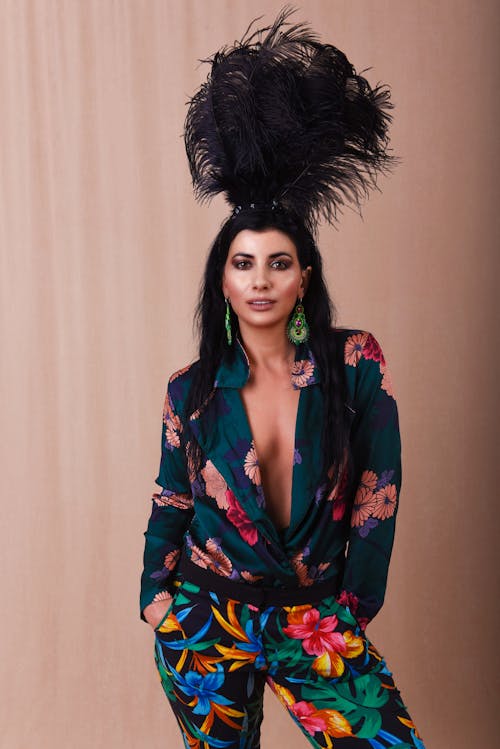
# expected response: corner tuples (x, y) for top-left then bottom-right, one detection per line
(140, 375), (193, 621)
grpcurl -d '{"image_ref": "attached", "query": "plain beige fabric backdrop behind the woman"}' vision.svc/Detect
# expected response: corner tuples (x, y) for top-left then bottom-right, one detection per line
(0, 0), (500, 749)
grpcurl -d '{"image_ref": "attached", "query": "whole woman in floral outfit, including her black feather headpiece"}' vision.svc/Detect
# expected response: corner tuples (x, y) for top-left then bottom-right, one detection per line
(141, 7), (423, 749)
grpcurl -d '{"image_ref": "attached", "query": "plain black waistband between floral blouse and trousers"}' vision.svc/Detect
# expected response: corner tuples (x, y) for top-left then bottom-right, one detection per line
(179, 554), (336, 608)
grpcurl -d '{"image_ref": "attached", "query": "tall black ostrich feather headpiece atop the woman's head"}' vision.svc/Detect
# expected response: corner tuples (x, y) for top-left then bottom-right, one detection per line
(184, 6), (397, 230)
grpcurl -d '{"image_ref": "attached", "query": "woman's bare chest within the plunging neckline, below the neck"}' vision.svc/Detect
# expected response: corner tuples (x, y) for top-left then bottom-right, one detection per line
(240, 374), (300, 529)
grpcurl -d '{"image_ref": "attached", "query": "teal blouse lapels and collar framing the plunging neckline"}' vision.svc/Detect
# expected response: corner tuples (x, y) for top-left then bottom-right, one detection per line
(190, 338), (322, 545)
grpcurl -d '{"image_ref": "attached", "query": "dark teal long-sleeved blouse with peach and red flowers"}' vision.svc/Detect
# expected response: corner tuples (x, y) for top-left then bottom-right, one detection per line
(140, 328), (401, 629)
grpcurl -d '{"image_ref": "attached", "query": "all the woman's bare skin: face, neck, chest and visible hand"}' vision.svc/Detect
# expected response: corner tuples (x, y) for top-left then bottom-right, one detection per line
(144, 229), (311, 628)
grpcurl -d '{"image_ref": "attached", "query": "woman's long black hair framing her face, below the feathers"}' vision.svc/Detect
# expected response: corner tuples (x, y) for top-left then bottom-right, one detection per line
(184, 207), (351, 491)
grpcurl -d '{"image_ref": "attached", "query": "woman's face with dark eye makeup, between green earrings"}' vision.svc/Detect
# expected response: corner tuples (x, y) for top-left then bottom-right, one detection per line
(222, 229), (311, 333)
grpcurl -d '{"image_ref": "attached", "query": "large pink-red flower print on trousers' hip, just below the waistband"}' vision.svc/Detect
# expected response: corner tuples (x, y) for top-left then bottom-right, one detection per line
(283, 608), (346, 655)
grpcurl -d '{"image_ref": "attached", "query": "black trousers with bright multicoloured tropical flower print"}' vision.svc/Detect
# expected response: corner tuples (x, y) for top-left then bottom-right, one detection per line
(155, 578), (424, 749)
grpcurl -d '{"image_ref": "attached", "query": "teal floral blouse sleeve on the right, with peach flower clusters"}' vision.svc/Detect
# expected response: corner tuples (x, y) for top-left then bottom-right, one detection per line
(339, 332), (401, 629)
